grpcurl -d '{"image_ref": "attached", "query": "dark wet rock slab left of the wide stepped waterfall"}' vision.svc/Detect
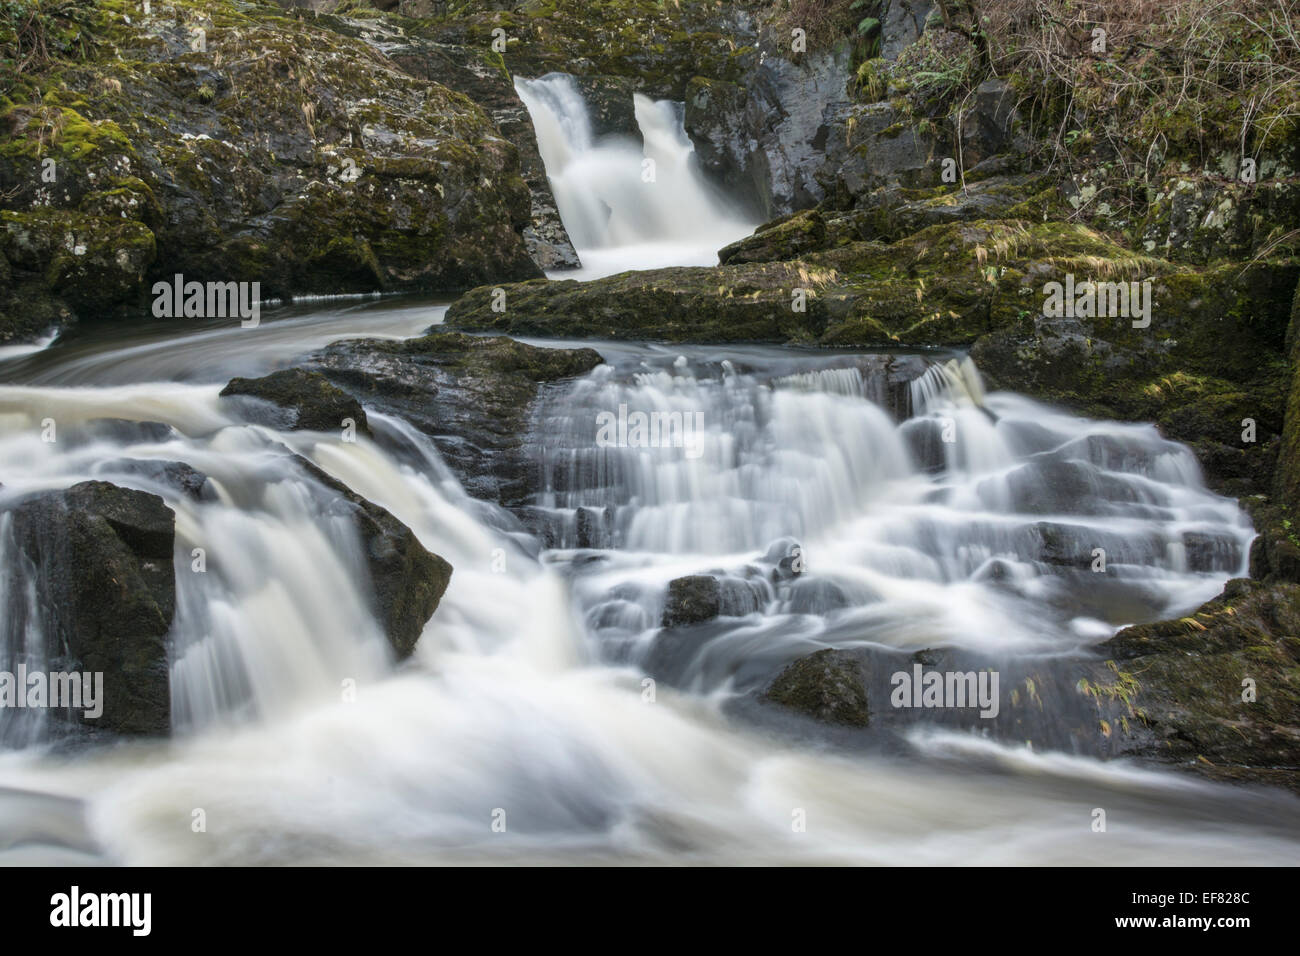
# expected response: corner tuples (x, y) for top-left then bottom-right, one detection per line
(308, 332), (602, 507)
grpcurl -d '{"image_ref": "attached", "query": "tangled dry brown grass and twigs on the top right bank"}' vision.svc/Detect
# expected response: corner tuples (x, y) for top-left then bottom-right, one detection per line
(980, 0), (1300, 170)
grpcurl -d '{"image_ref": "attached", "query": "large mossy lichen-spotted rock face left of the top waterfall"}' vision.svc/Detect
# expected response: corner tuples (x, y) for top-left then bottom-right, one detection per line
(0, 0), (540, 339)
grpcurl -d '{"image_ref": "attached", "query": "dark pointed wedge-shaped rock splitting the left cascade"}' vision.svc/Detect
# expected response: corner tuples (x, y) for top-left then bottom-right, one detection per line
(295, 455), (451, 661)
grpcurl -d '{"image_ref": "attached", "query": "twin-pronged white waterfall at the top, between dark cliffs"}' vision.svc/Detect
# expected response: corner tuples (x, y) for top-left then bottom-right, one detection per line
(515, 73), (757, 278)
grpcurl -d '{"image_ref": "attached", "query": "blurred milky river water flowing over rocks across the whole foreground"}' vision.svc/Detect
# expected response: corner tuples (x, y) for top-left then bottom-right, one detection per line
(0, 81), (1300, 864)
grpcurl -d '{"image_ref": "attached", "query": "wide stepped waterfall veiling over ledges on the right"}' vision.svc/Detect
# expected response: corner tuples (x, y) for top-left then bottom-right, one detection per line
(541, 356), (1253, 689)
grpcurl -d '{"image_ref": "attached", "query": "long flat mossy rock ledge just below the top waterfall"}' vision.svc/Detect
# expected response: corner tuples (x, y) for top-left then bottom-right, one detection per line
(446, 220), (1121, 347)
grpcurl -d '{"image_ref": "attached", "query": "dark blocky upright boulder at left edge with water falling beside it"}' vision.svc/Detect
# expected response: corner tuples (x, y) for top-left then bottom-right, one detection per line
(7, 481), (176, 735)
